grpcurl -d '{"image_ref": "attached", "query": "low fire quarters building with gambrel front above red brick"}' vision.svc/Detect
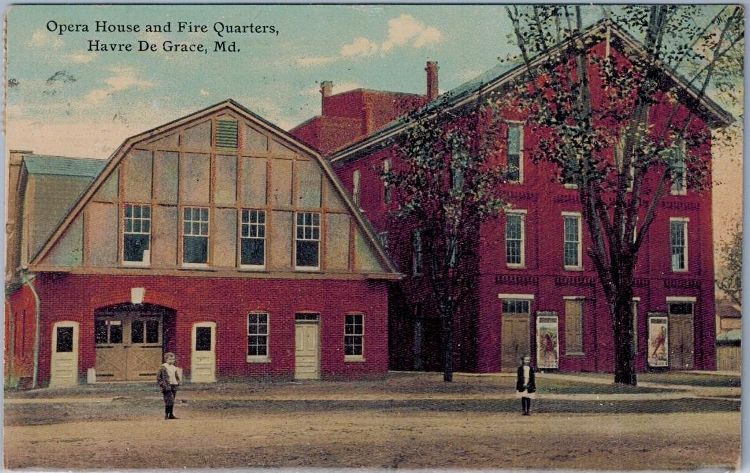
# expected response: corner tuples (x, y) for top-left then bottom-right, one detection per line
(5, 100), (399, 386)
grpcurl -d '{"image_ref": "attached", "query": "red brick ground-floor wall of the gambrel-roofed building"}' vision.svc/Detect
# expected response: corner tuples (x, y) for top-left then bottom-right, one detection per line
(32, 275), (388, 383)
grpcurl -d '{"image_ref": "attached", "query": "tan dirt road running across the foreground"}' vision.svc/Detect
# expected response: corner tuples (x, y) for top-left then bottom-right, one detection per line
(5, 407), (740, 470)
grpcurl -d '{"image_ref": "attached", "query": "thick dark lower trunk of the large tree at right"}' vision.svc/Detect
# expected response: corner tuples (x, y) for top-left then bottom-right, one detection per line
(610, 278), (637, 386)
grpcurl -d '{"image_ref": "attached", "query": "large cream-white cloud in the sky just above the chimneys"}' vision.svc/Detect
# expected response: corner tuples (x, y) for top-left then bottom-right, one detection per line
(295, 14), (443, 67)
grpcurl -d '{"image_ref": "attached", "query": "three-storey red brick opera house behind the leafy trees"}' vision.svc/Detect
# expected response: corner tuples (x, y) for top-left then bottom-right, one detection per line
(311, 25), (733, 372)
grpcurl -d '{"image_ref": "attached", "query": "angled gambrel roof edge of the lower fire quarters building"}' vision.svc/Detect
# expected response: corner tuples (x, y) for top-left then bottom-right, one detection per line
(30, 99), (399, 279)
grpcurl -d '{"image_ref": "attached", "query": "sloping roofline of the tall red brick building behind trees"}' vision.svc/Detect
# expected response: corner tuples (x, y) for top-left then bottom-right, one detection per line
(329, 19), (735, 164)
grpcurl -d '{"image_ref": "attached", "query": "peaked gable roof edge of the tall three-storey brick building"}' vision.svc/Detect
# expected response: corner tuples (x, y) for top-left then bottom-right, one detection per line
(330, 20), (735, 163)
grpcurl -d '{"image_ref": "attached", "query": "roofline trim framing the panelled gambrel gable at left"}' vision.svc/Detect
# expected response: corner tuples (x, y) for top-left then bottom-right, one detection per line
(29, 99), (398, 274)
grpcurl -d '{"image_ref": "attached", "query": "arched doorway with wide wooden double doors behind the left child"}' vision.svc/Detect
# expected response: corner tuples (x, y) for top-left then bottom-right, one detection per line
(94, 303), (175, 382)
